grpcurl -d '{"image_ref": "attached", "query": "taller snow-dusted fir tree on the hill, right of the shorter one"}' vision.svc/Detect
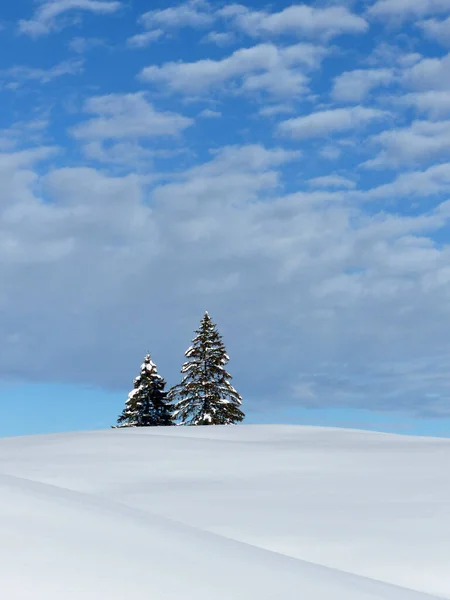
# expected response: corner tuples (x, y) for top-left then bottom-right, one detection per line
(168, 312), (245, 425)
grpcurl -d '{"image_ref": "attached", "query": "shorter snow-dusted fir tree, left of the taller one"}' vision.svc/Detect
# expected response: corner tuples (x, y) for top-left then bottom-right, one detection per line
(116, 354), (173, 427)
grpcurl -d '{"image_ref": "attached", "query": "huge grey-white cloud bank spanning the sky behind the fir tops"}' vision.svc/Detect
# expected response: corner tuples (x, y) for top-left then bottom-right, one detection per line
(4, 139), (450, 415)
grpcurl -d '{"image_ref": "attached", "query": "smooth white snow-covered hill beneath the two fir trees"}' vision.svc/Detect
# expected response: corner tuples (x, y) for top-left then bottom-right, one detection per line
(0, 425), (450, 600)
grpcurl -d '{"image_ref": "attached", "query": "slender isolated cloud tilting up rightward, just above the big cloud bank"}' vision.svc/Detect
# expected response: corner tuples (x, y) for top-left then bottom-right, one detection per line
(278, 106), (389, 139)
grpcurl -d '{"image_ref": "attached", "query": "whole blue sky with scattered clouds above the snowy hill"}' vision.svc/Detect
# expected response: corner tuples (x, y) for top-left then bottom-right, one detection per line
(0, 0), (450, 435)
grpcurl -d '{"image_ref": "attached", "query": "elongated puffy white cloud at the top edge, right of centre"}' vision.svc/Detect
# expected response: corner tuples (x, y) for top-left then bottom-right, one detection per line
(219, 4), (368, 39)
